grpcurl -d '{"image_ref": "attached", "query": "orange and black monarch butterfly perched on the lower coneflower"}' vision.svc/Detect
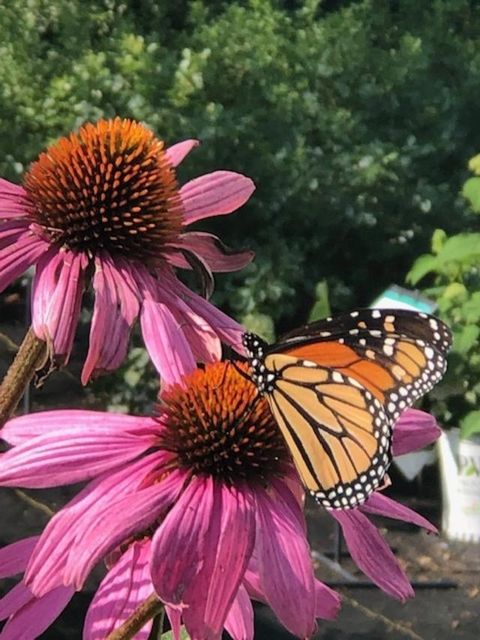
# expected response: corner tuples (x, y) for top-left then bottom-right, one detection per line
(243, 309), (451, 509)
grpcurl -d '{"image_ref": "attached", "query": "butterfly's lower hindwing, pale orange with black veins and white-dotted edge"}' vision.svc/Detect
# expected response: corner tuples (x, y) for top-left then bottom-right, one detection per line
(265, 353), (391, 509)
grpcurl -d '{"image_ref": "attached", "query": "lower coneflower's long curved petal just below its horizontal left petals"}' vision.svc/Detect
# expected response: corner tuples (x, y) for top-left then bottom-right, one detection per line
(25, 452), (172, 596)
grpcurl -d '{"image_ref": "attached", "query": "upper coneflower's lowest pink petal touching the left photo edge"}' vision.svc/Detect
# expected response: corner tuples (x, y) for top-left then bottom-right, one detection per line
(0, 227), (48, 291)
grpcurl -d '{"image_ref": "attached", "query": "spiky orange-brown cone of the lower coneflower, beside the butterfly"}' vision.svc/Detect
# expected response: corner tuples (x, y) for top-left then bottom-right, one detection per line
(161, 362), (288, 484)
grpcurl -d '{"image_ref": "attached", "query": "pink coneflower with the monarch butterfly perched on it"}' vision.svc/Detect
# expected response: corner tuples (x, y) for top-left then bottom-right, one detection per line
(0, 363), (339, 640)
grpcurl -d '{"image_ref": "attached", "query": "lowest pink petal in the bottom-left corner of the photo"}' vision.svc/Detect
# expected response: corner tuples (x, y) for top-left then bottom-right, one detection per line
(1, 585), (74, 640)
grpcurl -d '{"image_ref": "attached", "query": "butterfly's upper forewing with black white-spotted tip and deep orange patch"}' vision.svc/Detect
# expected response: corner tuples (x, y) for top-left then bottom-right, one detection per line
(269, 309), (451, 420)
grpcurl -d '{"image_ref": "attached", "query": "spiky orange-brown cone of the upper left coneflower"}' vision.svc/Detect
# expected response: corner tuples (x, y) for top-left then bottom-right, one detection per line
(24, 118), (182, 261)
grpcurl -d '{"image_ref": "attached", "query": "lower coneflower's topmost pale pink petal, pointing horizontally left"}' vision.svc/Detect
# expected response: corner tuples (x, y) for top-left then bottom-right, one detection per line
(2, 409), (162, 446)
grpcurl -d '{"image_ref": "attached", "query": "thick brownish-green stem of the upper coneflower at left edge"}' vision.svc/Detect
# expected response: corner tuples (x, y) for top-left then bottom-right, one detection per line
(0, 329), (47, 427)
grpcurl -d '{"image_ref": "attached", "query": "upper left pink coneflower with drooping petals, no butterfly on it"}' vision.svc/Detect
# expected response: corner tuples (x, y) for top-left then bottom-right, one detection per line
(0, 118), (254, 383)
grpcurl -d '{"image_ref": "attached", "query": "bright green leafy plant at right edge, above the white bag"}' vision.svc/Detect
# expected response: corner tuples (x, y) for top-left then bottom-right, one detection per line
(407, 156), (480, 437)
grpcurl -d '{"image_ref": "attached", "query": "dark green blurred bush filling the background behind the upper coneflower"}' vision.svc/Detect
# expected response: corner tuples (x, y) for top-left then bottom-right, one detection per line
(0, 0), (480, 410)
